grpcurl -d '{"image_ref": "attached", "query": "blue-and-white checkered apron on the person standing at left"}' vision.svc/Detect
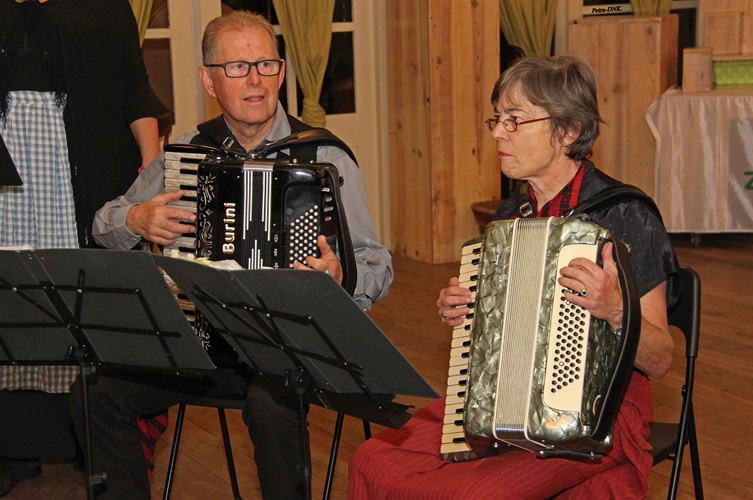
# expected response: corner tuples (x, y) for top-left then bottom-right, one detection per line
(0, 91), (79, 392)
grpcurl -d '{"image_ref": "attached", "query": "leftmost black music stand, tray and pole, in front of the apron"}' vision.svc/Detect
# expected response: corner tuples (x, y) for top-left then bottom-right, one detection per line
(0, 249), (215, 498)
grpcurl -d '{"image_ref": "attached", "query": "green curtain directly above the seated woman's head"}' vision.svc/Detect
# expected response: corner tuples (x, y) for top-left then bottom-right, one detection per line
(499, 0), (557, 56)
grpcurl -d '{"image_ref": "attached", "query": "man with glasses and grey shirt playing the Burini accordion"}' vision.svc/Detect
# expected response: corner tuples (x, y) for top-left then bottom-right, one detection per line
(73, 11), (392, 499)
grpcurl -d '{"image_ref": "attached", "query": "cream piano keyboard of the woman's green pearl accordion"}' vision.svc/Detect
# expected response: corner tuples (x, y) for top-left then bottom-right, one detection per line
(439, 242), (481, 461)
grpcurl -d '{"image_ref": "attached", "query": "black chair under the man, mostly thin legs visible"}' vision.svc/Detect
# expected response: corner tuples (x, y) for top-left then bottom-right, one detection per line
(162, 398), (371, 500)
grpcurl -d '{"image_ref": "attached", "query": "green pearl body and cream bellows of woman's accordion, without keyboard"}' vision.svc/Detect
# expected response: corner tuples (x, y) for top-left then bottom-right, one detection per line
(464, 218), (634, 456)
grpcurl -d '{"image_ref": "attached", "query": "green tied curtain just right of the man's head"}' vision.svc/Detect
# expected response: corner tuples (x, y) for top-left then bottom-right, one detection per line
(273, 0), (335, 127)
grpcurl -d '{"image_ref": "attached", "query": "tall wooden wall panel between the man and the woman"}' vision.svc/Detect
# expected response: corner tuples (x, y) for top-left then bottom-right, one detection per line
(387, 0), (500, 263)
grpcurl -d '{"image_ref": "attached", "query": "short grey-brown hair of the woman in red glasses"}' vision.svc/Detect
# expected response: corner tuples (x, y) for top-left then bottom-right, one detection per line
(492, 56), (603, 160)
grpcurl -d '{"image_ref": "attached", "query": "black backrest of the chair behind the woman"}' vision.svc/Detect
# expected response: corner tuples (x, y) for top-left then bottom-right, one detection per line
(667, 267), (701, 358)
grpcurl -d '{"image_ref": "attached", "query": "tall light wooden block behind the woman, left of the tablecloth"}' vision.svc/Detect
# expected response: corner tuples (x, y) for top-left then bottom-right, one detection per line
(568, 14), (678, 194)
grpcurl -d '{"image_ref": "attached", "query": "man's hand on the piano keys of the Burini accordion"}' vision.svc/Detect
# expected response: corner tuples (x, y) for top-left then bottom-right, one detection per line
(126, 191), (196, 245)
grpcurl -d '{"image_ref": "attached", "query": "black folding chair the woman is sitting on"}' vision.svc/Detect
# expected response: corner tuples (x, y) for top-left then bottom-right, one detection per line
(649, 267), (703, 499)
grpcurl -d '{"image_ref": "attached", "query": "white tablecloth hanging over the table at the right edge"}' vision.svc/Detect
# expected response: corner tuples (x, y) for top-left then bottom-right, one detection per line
(646, 87), (753, 233)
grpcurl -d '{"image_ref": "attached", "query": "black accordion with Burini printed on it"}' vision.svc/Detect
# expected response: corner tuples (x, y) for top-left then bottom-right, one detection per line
(164, 144), (356, 361)
